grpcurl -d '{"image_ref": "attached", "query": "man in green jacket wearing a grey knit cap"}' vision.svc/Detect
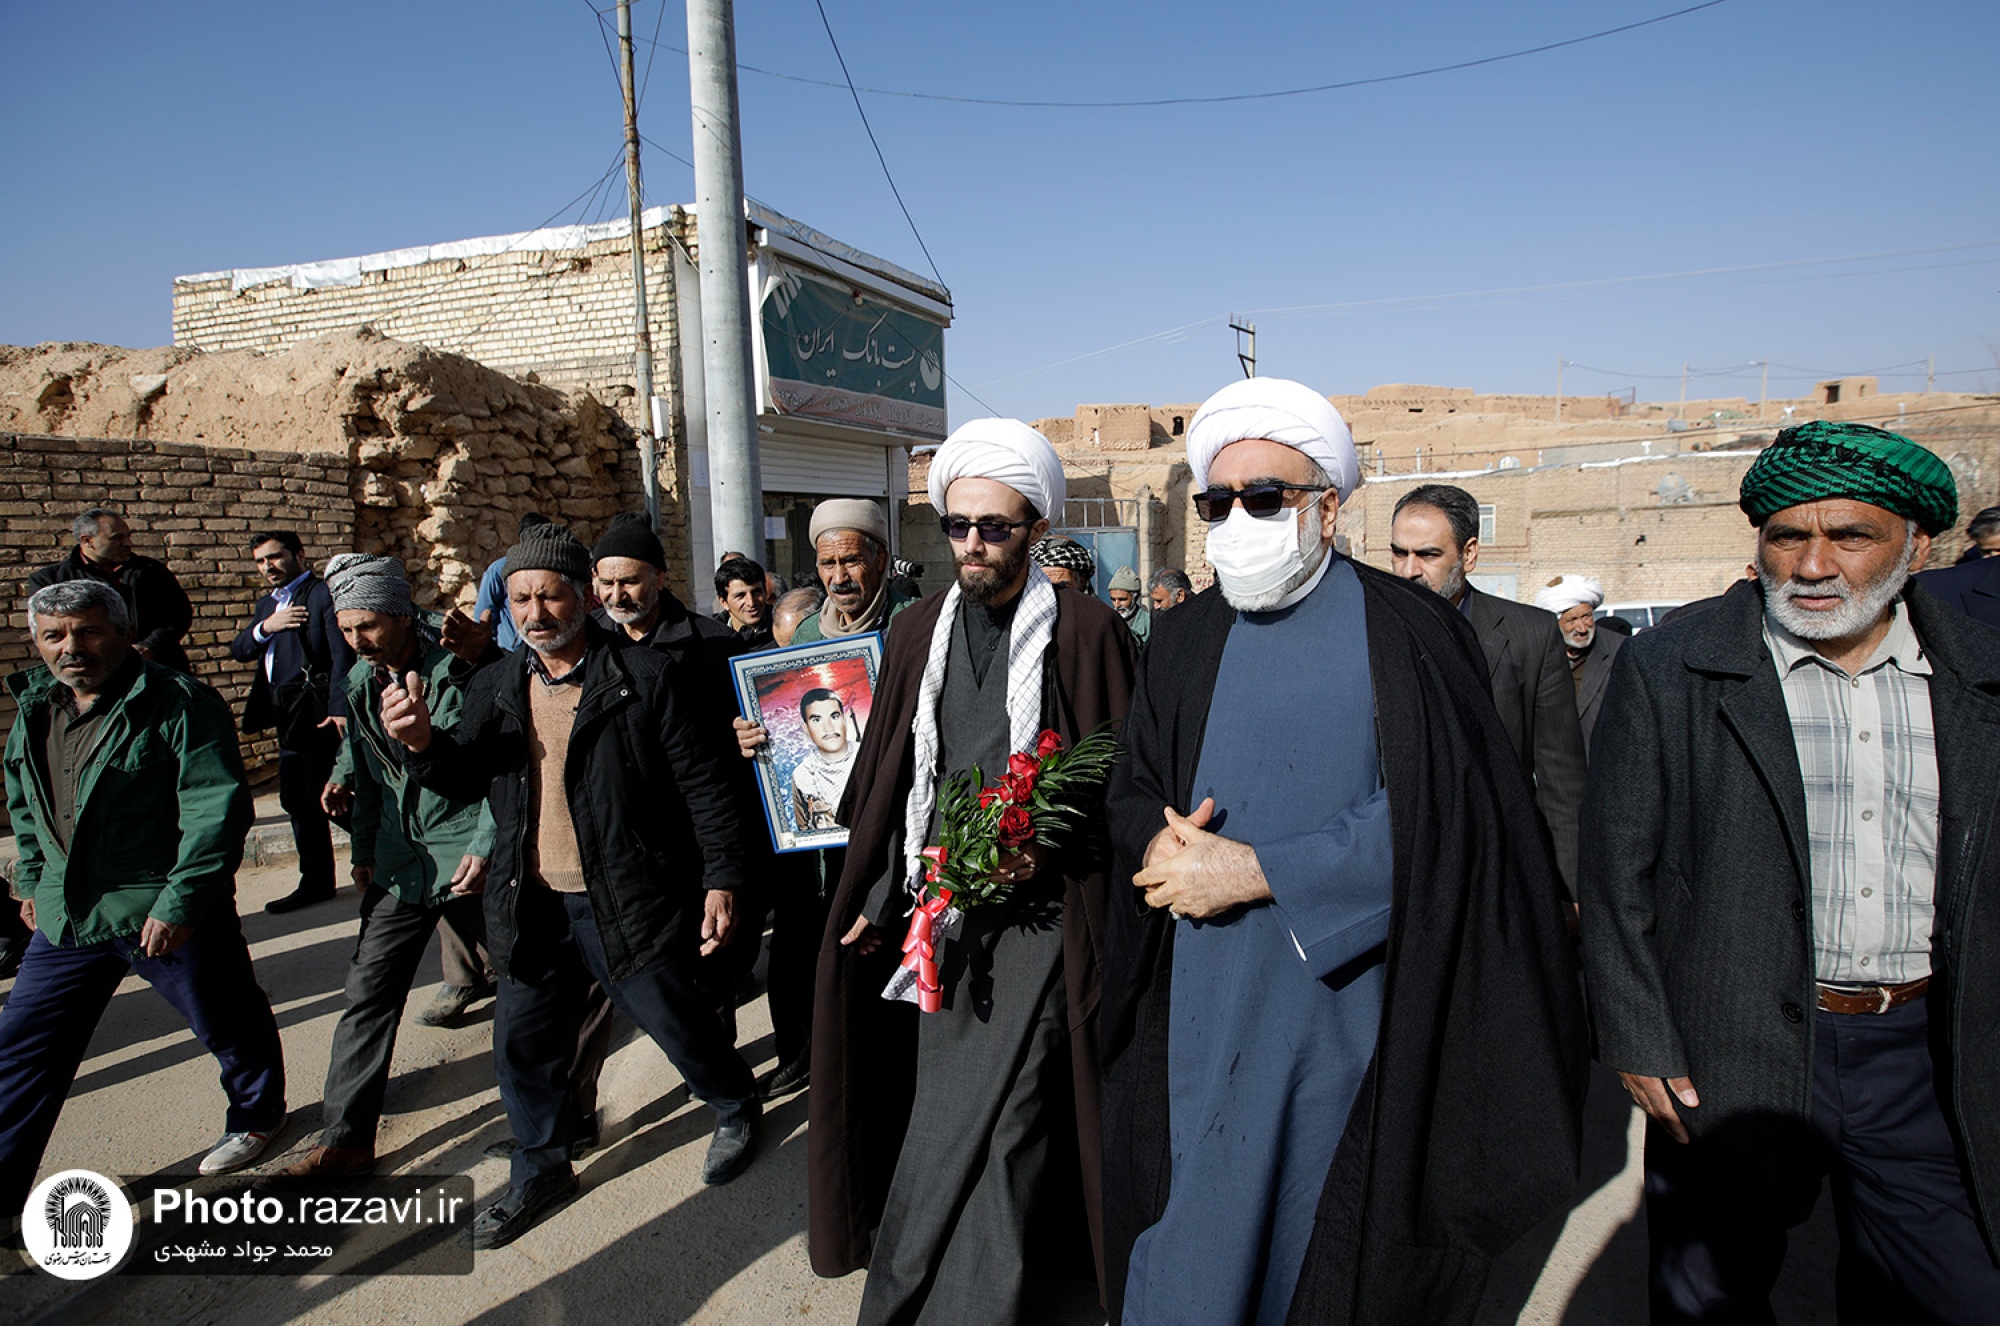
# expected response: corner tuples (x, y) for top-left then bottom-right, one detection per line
(284, 552), (494, 1180)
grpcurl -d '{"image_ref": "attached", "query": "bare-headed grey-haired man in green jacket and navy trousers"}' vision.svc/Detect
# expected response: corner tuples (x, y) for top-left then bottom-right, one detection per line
(0, 580), (284, 1212)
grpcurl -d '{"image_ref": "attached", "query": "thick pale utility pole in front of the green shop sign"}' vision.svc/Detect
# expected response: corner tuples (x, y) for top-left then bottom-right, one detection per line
(688, 0), (768, 564)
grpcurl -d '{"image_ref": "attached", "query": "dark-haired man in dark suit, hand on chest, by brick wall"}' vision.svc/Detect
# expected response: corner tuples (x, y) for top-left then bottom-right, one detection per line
(230, 530), (354, 912)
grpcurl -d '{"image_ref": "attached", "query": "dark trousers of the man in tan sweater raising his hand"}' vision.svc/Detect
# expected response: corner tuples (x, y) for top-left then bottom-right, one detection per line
(494, 888), (756, 1188)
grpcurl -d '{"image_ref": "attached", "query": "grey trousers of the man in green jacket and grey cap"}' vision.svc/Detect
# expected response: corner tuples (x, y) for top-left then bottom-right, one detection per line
(320, 888), (492, 1150)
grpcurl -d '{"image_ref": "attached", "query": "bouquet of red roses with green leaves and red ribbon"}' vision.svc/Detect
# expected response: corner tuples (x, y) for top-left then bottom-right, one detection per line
(890, 726), (1118, 1012)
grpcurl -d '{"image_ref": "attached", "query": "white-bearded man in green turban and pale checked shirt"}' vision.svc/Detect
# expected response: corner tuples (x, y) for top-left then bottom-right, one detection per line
(1582, 422), (2000, 1322)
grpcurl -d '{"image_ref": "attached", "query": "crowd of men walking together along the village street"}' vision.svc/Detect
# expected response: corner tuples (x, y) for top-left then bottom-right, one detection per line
(0, 390), (2000, 1326)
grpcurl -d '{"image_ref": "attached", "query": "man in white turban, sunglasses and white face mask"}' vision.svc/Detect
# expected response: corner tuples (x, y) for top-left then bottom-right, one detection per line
(1104, 378), (1584, 1326)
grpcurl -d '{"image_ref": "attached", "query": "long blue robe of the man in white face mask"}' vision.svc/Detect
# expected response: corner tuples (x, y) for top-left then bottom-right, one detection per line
(1124, 560), (1392, 1326)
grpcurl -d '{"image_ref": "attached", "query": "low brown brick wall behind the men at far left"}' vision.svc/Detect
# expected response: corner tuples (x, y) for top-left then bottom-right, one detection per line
(0, 432), (354, 778)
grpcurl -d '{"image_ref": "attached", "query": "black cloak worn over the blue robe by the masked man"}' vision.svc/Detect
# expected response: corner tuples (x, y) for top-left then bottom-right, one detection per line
(1100, 564), (1586, 1326)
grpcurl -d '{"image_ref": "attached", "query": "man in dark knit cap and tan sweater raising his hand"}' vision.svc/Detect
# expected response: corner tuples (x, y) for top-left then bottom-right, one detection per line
(382, 526), (760, 1248)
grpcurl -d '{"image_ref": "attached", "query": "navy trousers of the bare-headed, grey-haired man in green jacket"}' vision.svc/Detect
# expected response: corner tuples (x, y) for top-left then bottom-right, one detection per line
(0, 902), (284, 1212)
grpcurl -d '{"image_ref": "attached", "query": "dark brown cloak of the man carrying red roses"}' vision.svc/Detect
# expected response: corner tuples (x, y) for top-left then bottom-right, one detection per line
(806, 592), (1136, 1276)
